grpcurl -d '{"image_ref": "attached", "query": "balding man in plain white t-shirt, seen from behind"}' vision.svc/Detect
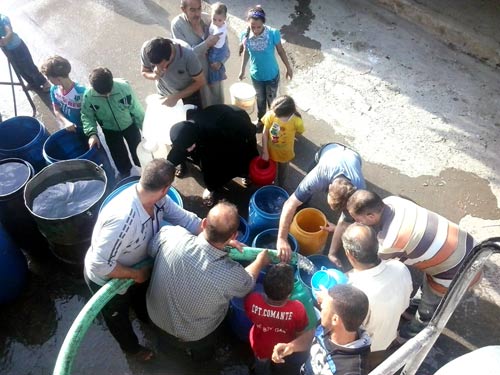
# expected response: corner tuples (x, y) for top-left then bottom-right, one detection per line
(342, 223), (413, 352)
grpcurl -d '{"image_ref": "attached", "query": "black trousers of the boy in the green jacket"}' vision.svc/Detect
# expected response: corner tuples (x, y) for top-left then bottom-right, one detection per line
(102, 124), (141, 174)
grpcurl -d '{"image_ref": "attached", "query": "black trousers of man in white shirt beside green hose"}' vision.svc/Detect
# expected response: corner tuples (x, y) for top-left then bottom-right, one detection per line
(84, 274), (149, 354)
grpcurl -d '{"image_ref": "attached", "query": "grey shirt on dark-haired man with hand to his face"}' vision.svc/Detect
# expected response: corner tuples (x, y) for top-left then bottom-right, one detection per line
(141, 39), (202, 96)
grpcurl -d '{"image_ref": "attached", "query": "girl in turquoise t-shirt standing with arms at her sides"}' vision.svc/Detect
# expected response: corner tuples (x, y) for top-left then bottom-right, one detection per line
(239, 5), (293, 131)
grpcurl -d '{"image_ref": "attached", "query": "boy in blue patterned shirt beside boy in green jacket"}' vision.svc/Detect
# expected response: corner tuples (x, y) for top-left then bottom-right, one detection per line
(42, 56), (85, 134)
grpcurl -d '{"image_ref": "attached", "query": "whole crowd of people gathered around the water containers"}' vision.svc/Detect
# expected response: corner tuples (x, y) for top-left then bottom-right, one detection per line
(0, 0), (475, 374)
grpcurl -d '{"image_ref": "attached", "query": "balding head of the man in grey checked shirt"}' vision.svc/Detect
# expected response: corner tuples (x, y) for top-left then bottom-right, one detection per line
(205, 201), (240, 244)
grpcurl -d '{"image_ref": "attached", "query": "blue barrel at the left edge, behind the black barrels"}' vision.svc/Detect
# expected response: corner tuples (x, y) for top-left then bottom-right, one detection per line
(0, 116), (49, 173)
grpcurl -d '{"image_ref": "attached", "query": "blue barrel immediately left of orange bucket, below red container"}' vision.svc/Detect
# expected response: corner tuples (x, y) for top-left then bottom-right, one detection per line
(248, 185), (288, 235)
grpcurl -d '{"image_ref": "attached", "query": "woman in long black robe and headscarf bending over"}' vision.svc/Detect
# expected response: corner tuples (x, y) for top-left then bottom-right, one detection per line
(167, 104), (259, 205)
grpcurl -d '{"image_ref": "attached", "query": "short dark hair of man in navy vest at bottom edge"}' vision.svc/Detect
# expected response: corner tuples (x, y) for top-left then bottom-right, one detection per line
(328, 284), (369, 332)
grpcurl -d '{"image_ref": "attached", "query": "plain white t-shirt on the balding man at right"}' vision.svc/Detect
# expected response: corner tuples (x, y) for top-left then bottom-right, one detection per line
(349, 260), (412, 351)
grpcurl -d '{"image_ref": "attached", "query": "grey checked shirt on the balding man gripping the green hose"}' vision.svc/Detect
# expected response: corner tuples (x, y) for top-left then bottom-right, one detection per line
(147, 227), (254, 341)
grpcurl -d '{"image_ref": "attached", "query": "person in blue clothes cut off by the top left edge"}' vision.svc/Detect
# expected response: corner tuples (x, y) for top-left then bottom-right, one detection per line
(0, 14), (50, 92)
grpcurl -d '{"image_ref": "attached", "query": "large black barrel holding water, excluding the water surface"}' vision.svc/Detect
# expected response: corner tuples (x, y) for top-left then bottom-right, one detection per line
(24, 159), (107, 265)
